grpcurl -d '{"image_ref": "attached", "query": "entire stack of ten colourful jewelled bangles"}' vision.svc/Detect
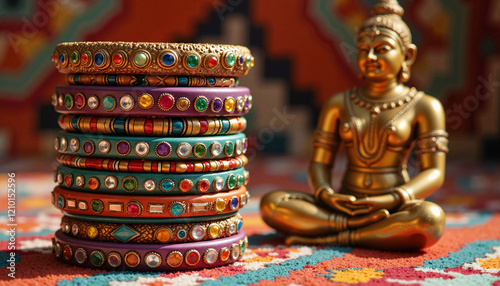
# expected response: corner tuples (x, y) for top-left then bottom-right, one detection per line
(51, 42), (254, 271)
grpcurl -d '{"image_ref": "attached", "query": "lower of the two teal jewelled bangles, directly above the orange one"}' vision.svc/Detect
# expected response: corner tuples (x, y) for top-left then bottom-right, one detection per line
(54, 165), (250, 196)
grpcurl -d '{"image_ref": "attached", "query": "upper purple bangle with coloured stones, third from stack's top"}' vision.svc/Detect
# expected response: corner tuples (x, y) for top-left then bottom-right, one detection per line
(52, 85), (252, 117)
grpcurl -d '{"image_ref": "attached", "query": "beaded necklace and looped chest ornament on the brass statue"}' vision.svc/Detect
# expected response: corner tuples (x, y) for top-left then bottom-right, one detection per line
(343, 87), (423, 165)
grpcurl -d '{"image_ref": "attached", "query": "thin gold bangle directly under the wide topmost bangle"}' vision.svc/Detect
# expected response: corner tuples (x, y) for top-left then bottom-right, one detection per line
(66, 74), (239, 87)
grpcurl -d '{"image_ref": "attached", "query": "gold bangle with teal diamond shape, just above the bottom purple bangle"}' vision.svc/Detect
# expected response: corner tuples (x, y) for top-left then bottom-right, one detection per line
(61, 214), (243, 243)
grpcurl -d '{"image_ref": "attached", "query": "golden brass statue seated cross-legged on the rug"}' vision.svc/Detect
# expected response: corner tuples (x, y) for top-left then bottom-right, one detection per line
(260, 0), (448, 251)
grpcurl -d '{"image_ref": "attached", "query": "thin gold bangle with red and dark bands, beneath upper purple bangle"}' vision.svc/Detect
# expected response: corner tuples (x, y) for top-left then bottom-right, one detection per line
(57, 114), (247, 137)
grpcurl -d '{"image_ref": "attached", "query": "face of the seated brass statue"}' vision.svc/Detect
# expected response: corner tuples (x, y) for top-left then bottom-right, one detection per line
(357, 34), (405, 81)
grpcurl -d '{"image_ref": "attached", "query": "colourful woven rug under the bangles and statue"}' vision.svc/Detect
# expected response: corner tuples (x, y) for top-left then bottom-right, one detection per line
(0, 159), (500, 286)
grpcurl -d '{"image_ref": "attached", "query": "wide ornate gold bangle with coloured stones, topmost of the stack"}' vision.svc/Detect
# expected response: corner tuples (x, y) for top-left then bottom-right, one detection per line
(52, 42), (254, 77)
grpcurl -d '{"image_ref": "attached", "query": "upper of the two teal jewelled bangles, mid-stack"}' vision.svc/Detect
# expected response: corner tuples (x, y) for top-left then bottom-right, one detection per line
(54, 132), (248, 160)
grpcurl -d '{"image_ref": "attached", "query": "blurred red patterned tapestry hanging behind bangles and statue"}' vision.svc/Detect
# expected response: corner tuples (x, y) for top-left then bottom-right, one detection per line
(0, 0), (500, 160)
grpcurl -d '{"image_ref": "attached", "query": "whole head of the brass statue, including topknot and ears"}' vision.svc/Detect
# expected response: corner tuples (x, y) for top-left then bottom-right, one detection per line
(357, 0), (417, 82)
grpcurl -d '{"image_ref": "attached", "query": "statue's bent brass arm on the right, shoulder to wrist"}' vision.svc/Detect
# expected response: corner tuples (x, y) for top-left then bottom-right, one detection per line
(395, 95), (448, 203)
